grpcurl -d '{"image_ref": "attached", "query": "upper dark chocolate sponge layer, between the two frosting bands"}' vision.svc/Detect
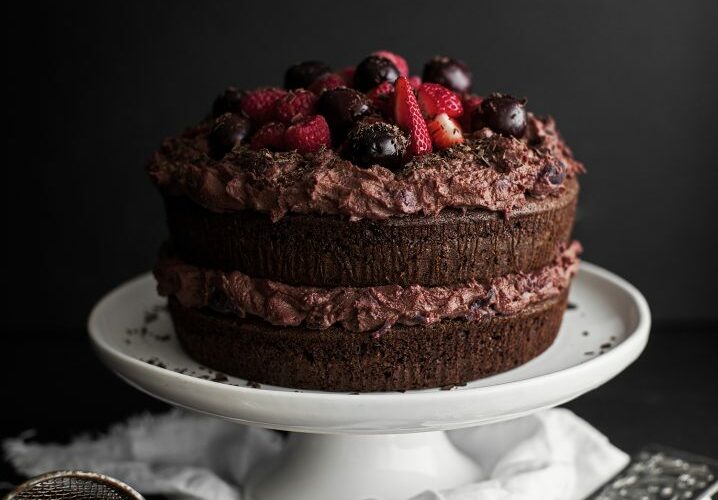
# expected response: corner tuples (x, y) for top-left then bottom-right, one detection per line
(165, 179), (578, 287)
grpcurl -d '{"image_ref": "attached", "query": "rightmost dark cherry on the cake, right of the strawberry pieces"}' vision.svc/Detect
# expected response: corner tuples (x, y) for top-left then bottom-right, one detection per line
(471, 94), (526, 137)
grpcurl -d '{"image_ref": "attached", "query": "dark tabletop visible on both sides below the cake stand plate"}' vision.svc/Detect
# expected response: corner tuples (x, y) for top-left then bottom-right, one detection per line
(0, 323), (718, 494)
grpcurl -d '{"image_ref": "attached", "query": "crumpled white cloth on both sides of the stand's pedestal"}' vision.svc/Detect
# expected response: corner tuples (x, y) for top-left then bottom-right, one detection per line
(3, 409), (628, 500)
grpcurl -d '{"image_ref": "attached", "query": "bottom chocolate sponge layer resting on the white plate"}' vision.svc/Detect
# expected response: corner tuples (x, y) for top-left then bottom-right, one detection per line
(169, 292), (567, 391)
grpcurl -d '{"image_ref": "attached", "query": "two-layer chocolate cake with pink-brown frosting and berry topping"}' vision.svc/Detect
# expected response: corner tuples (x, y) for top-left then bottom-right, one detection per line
(148, 51), (583, 391)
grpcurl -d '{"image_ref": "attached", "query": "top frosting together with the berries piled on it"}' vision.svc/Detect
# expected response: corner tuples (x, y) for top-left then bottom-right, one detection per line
(148, 52), (583, 221)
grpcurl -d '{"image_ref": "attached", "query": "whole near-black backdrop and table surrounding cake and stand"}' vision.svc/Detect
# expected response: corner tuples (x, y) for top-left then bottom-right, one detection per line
(0, 0), (718, 490)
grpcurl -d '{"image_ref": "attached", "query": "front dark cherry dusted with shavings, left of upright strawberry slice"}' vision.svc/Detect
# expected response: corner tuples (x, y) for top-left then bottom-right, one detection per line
(343, 122), (409, 169)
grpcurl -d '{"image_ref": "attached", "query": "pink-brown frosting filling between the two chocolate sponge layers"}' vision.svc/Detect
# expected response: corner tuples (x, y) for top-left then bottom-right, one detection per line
(155, 241), (582, 333)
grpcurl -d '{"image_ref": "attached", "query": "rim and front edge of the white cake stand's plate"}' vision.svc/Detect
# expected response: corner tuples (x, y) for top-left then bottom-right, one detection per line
(88, 262), (651, 433)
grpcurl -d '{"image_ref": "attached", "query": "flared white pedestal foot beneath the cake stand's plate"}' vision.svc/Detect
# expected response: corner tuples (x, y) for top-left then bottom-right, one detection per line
(247, 432), (481, 500)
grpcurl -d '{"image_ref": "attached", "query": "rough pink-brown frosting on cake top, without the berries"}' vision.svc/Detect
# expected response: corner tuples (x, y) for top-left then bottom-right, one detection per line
(147, 113), (584, 221)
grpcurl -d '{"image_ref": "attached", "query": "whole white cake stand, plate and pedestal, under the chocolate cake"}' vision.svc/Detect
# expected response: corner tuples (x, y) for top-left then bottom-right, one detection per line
(89, 263), (650, 500)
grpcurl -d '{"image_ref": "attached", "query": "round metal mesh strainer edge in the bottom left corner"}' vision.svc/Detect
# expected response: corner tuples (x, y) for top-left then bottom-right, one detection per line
(3, 470), (144, 500)
